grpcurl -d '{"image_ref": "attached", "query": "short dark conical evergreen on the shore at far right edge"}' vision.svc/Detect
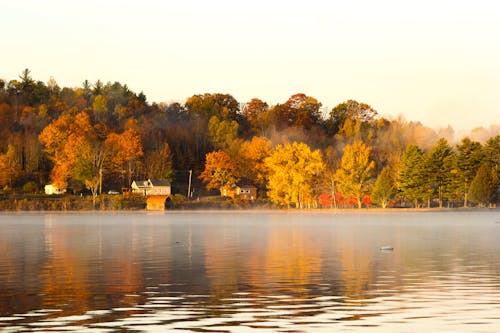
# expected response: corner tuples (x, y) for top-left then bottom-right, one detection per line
(469, 162), (498, 206)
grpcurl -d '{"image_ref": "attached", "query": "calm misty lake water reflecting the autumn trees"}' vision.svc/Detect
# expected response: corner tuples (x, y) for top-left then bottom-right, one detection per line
(0, 211), (500, 333)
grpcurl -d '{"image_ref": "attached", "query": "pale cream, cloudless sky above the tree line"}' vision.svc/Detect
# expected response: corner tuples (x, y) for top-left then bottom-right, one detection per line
(0, 0), (500, 130)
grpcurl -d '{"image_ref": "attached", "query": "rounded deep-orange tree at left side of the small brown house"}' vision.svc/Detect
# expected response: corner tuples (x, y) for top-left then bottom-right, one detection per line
(199, 150), (238, 195)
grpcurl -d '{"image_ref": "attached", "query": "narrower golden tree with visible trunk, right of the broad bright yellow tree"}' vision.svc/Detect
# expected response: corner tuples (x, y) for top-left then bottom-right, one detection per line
(335, 141), (375, 208)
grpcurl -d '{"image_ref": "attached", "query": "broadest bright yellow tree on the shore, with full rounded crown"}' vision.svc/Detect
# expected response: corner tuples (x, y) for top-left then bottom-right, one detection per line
(265, 142), (325, 208)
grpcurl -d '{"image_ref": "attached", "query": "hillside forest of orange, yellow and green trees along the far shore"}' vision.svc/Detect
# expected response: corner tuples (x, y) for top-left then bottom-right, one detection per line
(0, 69), (500, 208)
